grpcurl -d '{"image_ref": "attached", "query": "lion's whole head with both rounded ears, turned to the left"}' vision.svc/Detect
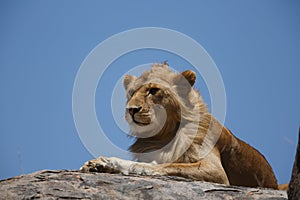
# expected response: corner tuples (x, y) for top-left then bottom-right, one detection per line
(123, 63), (204, 142)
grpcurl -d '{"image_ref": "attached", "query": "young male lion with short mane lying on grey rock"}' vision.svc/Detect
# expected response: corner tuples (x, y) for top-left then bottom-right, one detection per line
(81, 63), (278, 189)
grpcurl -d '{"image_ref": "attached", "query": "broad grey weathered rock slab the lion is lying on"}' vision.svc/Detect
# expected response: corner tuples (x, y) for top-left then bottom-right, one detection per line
(0, 170), (287, 200)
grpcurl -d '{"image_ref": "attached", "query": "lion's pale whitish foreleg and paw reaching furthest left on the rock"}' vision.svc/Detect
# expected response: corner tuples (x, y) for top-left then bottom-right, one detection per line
(80, 157), (164, 175)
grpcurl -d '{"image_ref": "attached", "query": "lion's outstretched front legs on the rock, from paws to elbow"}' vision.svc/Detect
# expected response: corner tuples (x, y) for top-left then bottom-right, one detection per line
(80, 155), (229, 185)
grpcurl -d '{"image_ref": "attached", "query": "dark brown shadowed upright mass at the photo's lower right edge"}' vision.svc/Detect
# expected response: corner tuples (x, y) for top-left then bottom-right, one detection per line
(288, 128), (300, 200)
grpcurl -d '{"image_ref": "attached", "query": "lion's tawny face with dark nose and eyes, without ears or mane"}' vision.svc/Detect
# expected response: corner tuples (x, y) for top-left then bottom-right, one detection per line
(125, 83), (180, 137)
